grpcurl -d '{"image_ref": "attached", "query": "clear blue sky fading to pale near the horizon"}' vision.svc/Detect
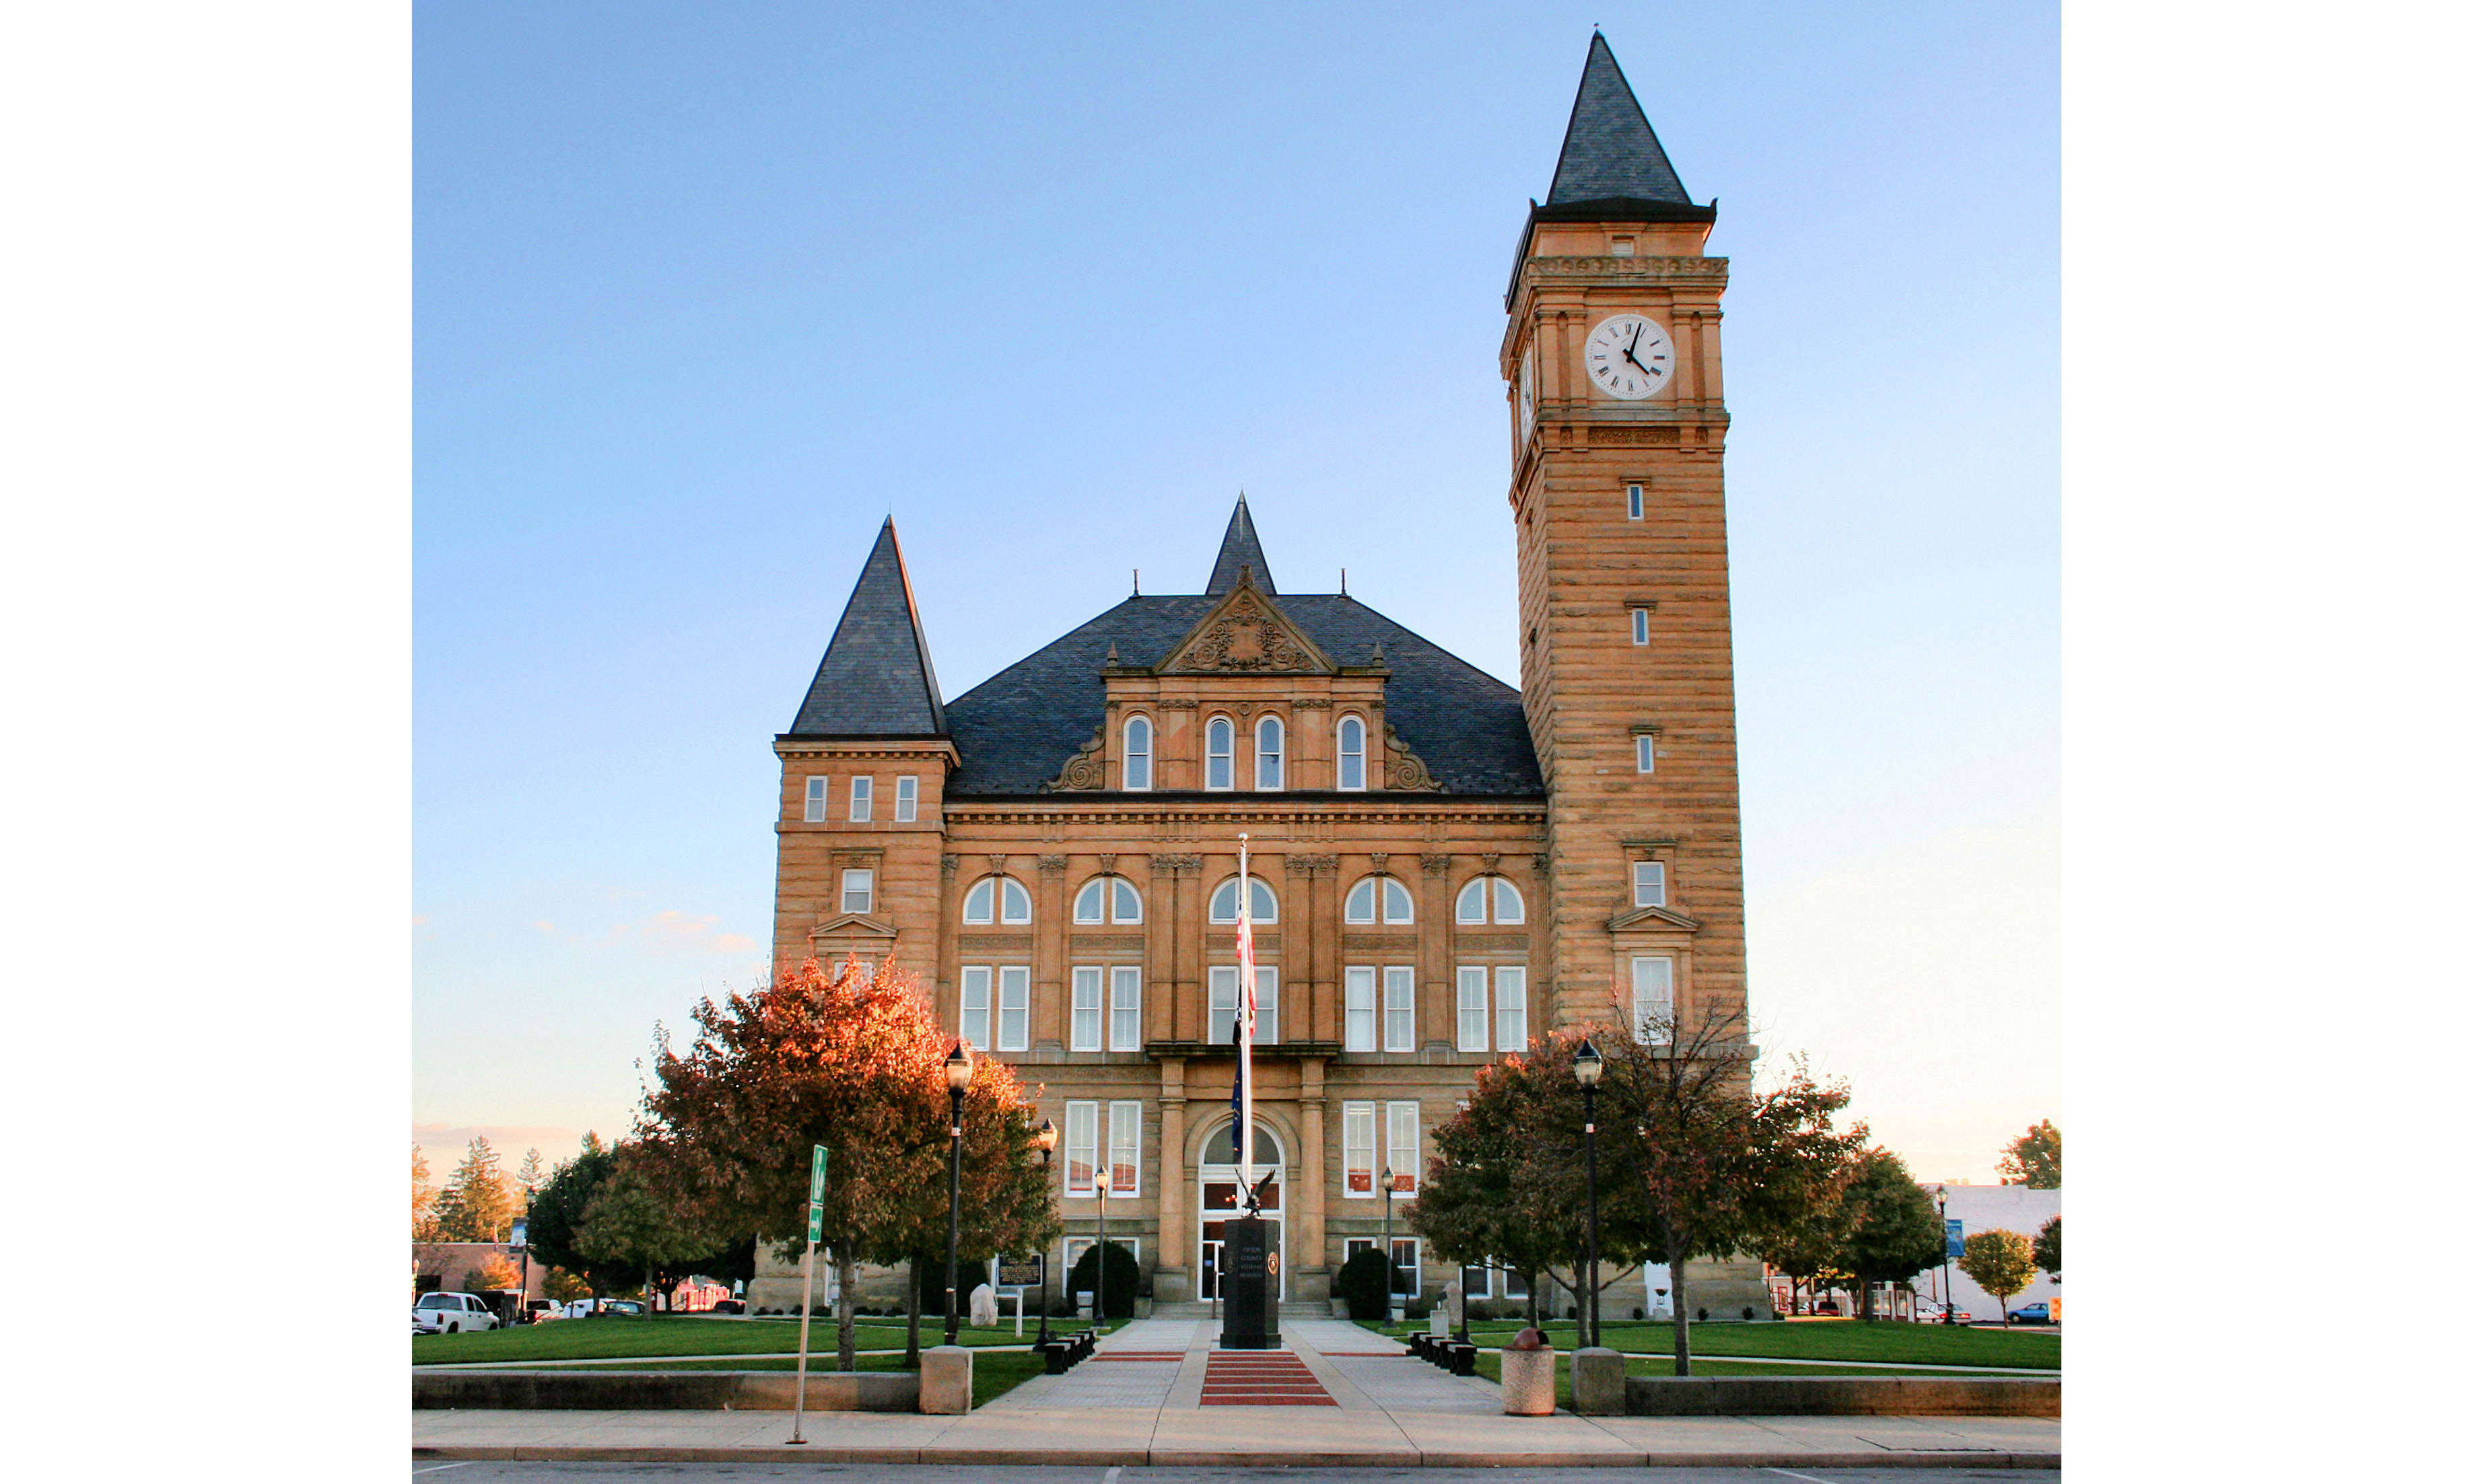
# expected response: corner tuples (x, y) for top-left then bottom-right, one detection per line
(413, 3), (2061, 1180)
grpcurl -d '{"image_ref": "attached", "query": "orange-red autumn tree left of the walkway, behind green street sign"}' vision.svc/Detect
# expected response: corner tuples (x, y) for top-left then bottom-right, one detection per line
(635, 960), (1064, 1370)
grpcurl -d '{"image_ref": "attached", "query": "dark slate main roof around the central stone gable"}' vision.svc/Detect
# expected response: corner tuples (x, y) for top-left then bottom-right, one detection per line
(945, 591), (1546, 796)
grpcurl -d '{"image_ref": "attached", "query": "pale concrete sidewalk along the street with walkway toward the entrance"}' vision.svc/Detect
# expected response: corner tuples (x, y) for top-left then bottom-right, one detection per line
(413, 1320), (2061, 1469)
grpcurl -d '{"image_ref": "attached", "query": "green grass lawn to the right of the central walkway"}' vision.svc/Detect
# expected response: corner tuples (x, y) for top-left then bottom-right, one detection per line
(1366, 1318), (2061, 1375)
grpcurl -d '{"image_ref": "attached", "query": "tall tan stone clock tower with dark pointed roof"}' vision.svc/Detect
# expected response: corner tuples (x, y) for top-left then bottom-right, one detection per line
(1502, 34), (1744, 1068)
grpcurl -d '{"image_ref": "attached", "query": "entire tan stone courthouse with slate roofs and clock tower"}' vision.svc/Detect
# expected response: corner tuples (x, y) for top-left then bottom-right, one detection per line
(747, 37), (1766, 1313)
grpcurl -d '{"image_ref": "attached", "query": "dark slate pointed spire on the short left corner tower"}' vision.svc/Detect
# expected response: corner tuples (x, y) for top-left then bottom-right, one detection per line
(792, 514), (945, 737)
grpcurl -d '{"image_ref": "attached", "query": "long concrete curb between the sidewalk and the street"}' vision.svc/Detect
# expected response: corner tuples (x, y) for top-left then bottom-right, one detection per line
(413, 1444), (2061, 1469)
